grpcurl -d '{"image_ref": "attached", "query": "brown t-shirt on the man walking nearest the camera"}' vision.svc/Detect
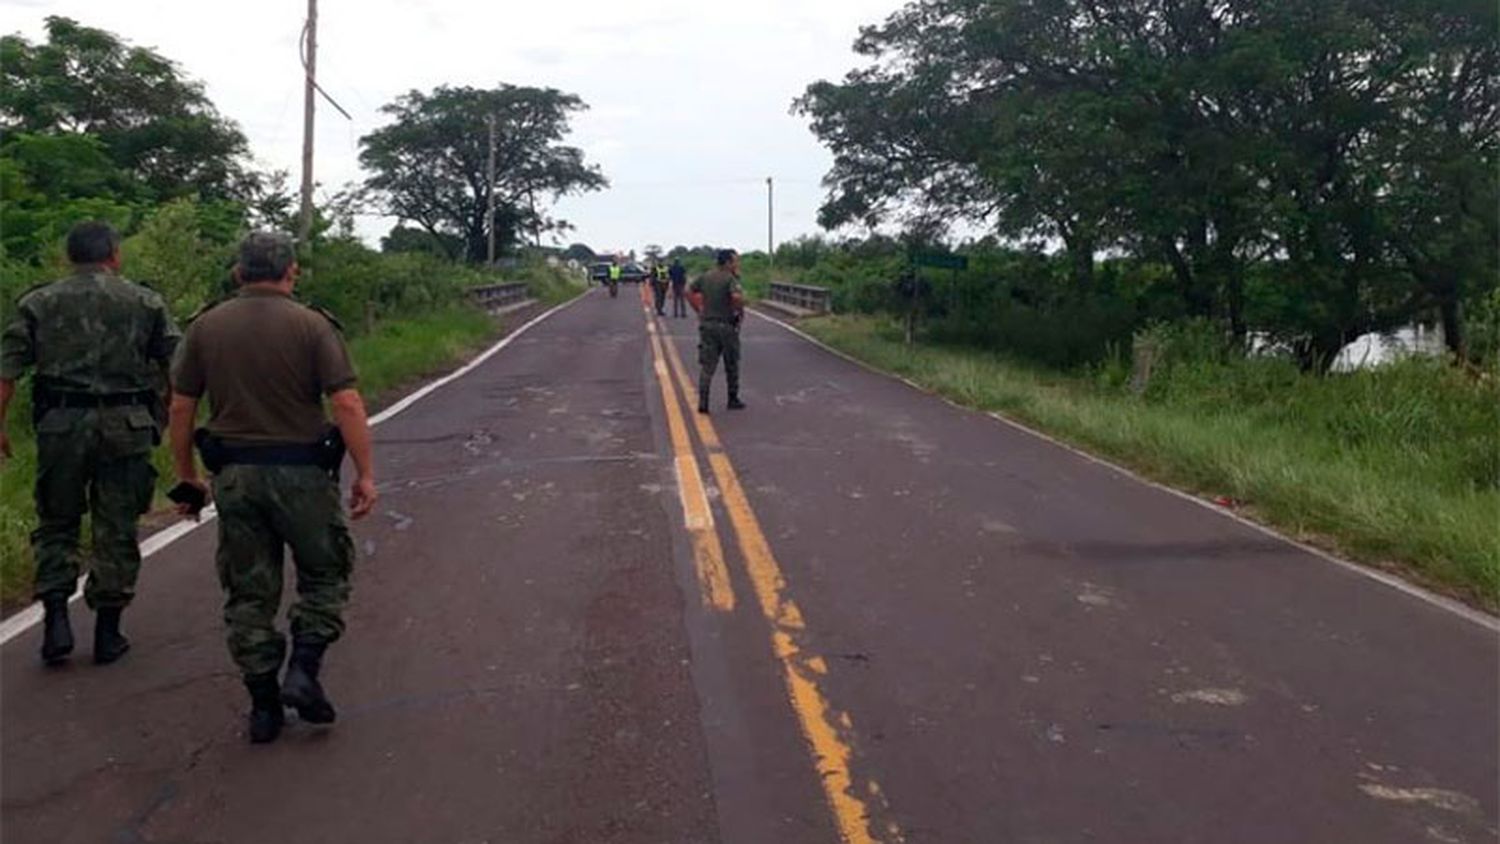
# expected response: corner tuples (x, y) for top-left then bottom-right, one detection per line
(173, 289), (356, 442)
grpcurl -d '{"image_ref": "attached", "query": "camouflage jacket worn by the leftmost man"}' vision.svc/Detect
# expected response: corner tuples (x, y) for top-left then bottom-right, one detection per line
(0, 267), (182, 396)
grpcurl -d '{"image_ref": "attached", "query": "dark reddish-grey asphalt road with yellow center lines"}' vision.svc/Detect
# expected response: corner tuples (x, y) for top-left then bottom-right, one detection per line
(0, 286), (1500, 844)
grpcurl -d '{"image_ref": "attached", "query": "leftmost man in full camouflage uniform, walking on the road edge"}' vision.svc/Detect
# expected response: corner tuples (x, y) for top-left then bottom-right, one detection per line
(0, 222), (182, 664)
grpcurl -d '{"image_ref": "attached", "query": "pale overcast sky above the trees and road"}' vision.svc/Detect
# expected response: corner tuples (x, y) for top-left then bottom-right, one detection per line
(0, 0), (900, 250)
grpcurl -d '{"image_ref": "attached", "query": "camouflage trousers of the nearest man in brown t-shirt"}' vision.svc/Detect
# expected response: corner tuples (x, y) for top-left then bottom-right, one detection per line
(213, 465), (354, 675)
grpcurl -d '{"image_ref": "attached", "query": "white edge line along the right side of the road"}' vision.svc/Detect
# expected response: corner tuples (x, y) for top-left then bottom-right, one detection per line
(752, 309), (1500, 633)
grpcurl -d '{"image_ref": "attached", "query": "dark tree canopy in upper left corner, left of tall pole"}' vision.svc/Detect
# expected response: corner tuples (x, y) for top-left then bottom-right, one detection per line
(0, 16), (249, 201)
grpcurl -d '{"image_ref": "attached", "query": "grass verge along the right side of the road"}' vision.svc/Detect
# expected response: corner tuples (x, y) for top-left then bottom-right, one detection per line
(800, 316), (1500, 612)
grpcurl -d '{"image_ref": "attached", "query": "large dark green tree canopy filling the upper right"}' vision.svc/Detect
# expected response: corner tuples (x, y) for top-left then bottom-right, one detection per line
(797, 0), (1500, 363)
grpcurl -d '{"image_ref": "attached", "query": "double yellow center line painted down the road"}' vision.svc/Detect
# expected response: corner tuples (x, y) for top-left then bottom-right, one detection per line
(647, 310), (902, 844)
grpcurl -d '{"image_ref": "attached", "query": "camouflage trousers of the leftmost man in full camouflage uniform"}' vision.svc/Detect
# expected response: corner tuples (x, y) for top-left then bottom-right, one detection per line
(32, 406), (158, 609)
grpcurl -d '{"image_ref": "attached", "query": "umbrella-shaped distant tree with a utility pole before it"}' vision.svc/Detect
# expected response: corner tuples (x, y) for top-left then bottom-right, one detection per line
(360, 85), (608, 261)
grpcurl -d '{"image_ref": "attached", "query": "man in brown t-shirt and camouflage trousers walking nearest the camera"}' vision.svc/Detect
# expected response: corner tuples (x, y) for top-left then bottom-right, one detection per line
(171, 232), (377, 744)
